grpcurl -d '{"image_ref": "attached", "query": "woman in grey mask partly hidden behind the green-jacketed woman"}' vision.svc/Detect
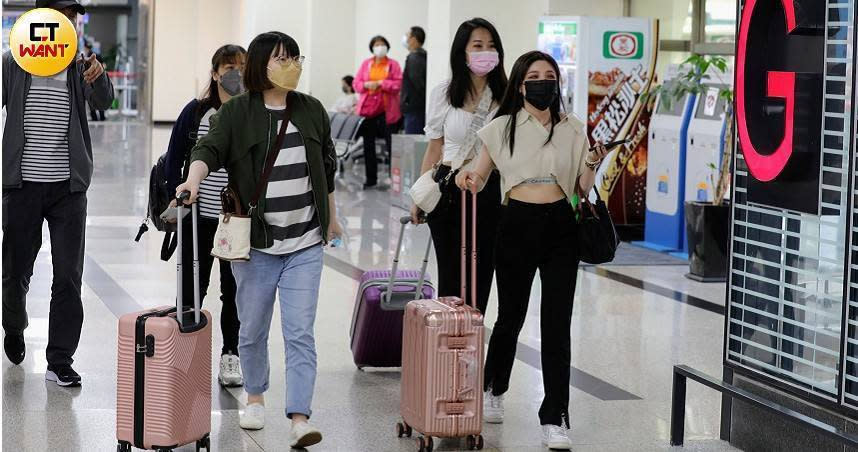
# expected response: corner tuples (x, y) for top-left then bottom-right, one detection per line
(166, 45), (247, 387)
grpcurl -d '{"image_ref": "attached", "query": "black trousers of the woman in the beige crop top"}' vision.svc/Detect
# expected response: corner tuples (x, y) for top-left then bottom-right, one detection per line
(485, 200), (578, 427)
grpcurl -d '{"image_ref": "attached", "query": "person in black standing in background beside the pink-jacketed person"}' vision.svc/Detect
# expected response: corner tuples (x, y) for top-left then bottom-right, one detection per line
(399, 27), (426, 134)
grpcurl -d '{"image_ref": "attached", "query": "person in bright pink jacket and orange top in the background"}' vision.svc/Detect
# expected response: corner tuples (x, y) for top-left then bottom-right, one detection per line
(352, 36), (402, 189)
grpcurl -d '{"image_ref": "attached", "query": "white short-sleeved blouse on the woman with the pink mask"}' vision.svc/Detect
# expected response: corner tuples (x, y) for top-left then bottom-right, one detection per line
(423, 80), (498, 163)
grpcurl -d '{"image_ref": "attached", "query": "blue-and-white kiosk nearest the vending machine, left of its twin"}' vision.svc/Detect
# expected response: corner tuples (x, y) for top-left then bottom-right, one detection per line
(635, 65), (696, 252)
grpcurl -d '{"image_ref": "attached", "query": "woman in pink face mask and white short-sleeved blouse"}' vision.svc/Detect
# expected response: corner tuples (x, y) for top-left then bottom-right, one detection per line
(411, 18), (507, 313)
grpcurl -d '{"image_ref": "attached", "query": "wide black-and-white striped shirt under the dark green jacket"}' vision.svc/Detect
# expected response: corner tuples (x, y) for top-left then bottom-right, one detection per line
(259, 107), (322, 255)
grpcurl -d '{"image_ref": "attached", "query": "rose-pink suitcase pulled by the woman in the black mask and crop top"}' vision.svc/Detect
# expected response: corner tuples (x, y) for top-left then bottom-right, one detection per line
(396, 192), (484, 452)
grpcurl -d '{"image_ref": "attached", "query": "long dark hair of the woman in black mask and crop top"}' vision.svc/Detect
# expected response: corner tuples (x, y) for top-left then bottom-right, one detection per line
(495, 50), (561, 155)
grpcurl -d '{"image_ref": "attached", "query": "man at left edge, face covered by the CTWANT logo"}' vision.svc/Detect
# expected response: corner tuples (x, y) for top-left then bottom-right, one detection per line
(2, 0), (113, 386)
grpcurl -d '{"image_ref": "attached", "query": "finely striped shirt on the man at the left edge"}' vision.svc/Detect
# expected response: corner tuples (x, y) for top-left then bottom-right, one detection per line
(21, 71), (71, 182)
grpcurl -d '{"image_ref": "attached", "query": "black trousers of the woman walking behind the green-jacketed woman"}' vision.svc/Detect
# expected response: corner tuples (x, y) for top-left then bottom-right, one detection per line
(177, 214), (241, 356)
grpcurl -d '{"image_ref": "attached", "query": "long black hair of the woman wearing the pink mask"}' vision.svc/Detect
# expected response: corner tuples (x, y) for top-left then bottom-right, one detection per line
(447, 17), (507, 108)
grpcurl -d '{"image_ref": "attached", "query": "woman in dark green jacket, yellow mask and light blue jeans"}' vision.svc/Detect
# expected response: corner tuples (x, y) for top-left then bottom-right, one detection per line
(176, 32), (342, 447)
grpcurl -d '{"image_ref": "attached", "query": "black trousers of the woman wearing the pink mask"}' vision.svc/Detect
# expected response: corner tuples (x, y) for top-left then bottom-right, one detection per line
(426, 172), (501, 313)
